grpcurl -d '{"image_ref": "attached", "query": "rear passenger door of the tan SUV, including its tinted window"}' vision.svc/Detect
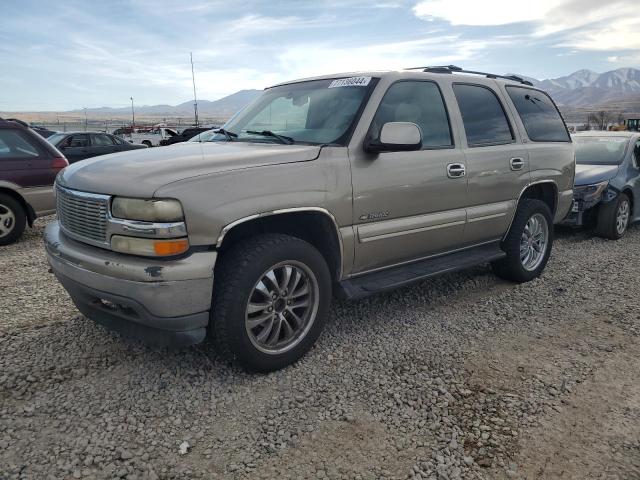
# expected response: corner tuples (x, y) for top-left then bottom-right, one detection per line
(453, 82), (530, 244)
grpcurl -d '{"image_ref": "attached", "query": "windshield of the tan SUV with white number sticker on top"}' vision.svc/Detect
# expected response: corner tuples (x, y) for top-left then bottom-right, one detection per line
(211, 77), (376, 145)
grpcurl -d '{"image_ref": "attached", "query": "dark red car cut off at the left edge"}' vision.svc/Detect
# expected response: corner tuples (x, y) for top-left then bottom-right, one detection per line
(0, 118), (69, 245)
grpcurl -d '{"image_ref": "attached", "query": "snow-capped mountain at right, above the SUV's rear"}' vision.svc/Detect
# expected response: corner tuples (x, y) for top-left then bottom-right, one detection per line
(520, 68), (640, 107)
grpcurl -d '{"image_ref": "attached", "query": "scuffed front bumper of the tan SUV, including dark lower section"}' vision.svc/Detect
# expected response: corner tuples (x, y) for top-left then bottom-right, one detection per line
(44, 222), (217, 346)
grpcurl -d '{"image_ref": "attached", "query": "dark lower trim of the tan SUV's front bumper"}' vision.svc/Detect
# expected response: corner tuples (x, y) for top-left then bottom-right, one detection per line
(54, 272), (209, 347)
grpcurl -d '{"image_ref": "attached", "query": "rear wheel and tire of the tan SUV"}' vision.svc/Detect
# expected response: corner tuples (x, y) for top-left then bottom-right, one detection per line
(491, 198), (553, 283)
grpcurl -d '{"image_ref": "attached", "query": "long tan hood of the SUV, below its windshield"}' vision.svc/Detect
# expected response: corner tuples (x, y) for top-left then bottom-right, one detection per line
(57, 142), (320, 197)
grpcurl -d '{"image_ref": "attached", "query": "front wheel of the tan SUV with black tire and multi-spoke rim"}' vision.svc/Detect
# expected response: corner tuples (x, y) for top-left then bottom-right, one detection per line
(209, 234), (332, 372)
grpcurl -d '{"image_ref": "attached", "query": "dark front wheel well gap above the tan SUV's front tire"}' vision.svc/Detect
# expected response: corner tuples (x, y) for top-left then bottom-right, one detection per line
(219, 212), (342, 281)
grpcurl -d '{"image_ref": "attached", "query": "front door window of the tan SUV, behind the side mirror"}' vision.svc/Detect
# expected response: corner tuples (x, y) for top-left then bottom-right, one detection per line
(370, 82), (453, 148)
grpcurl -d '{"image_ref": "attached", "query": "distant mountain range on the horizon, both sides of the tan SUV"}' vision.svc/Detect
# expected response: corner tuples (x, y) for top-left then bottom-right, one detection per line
(74, 68), (640, 118)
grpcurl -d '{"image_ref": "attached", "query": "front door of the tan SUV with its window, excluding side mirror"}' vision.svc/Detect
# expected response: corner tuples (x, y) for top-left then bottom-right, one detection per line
(349, 80), (467, 273)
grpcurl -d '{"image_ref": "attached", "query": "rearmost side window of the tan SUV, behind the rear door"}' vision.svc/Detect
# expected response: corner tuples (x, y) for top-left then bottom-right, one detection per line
(507, 87), (570, 142)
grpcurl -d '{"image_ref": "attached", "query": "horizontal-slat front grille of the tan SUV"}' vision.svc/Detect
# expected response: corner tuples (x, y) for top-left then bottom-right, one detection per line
(56, 186), (109, 244)
